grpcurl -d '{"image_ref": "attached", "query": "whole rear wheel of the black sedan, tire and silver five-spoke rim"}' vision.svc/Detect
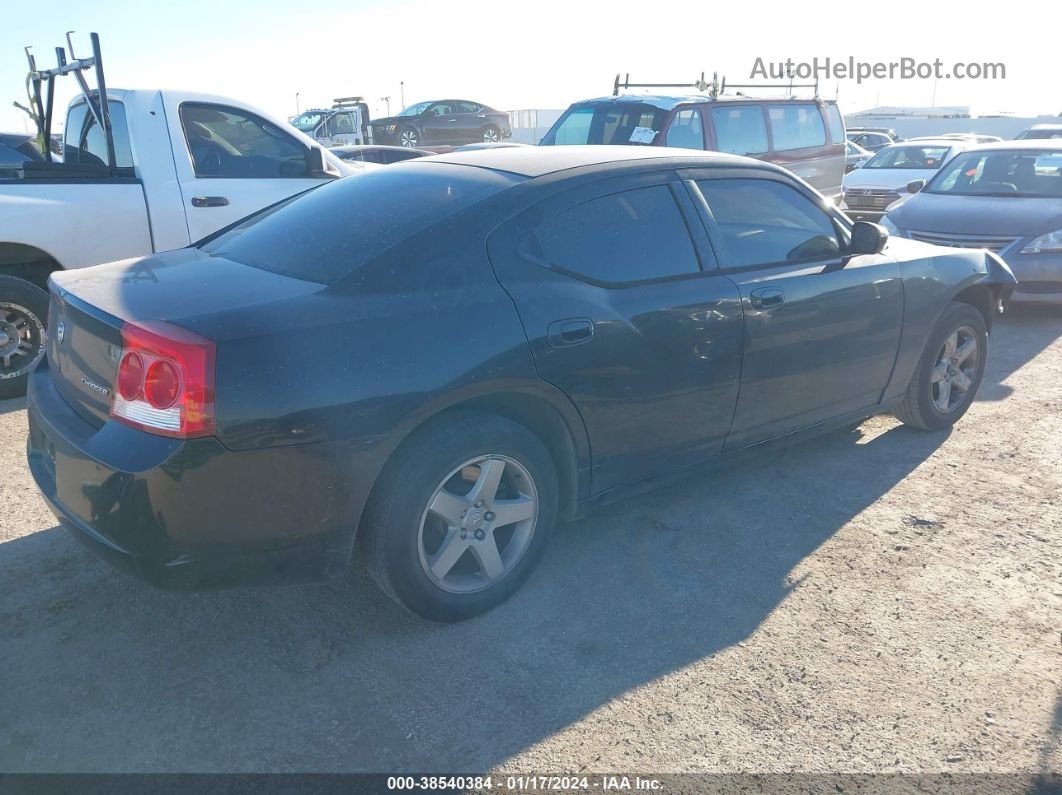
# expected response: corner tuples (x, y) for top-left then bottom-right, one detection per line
(358, 414), (558, 621)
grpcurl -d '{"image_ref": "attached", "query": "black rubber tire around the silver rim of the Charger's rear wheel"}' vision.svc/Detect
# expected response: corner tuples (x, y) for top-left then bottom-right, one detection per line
(358, 414), (558, 621)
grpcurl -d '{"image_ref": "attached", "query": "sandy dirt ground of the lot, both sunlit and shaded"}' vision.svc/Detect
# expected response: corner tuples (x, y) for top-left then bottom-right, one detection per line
(0, 309), (1062, 773)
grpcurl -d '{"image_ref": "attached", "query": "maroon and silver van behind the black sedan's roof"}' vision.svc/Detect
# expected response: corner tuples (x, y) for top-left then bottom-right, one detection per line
(538, 94), (845, 198)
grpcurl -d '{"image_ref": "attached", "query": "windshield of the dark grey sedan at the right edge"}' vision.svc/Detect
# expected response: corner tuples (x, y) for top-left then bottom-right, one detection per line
(925, 149), (1062, 198)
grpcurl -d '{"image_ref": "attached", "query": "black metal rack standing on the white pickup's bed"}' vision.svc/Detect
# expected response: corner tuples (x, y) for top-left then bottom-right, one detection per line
(15, 31), (116, 174)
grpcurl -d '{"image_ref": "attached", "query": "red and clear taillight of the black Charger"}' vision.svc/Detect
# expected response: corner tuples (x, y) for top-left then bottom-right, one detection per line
(110, 323), (215, 438)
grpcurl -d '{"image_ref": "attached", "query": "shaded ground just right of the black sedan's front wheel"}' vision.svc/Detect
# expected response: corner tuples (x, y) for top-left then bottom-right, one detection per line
(977, 304), (1062, 400)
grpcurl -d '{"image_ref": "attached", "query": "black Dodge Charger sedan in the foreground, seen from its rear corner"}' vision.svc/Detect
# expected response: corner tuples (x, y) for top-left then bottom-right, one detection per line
(29, 146), (1014, 620)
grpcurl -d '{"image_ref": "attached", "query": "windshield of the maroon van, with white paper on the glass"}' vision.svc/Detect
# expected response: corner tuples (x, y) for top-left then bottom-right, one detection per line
(542, 102), (668, 146)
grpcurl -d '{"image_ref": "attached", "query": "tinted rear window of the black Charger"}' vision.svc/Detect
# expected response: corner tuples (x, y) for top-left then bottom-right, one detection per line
(200, 162), (521, 284)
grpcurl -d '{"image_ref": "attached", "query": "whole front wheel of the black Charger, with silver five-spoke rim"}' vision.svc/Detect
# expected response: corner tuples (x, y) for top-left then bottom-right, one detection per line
(895, 304), (989, 431)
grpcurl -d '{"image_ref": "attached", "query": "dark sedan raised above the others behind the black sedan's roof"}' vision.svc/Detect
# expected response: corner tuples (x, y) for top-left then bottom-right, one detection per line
(373, 100), (513, 149)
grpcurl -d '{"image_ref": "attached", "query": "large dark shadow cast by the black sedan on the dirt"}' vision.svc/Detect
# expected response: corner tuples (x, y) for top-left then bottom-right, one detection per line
(0, 418), (946, 772)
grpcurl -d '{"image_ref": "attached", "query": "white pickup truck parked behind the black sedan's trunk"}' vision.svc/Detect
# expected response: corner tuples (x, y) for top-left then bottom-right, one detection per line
(0, 89), (365, 398)
